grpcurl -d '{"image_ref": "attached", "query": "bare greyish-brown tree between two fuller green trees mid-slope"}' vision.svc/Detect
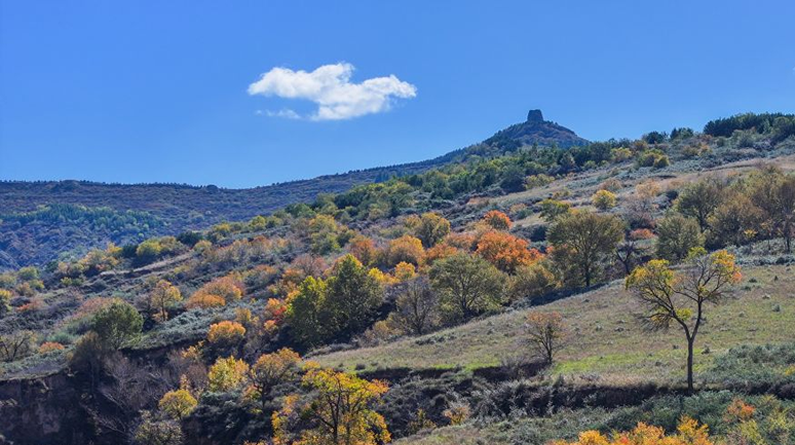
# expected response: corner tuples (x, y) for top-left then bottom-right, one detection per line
(390, 277), (439, 335)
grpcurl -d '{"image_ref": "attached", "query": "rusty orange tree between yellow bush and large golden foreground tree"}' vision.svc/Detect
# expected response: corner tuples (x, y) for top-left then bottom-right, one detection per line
(247, 348), (301, 411)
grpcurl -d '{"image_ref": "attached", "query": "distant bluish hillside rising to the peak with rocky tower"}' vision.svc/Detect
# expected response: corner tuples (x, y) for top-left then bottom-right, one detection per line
(0, 110), (587, 270)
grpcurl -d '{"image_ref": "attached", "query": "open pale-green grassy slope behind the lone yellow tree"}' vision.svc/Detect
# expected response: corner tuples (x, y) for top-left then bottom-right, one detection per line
(315, 266), (795, 383)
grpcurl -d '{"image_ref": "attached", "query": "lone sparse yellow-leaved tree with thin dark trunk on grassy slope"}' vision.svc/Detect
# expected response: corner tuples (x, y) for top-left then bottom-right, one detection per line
(626, 250), (741, 392)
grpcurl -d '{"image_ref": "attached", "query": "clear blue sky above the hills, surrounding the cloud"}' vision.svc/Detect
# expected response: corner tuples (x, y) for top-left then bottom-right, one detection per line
(0, 0), (795, 187)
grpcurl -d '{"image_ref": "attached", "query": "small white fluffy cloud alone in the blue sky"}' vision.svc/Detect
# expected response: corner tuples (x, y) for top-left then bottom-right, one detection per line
(248, 63), (417, 121)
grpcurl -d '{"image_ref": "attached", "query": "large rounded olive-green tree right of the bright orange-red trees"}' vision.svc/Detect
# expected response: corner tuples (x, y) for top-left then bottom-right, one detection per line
(547, 211), (624, 286)
